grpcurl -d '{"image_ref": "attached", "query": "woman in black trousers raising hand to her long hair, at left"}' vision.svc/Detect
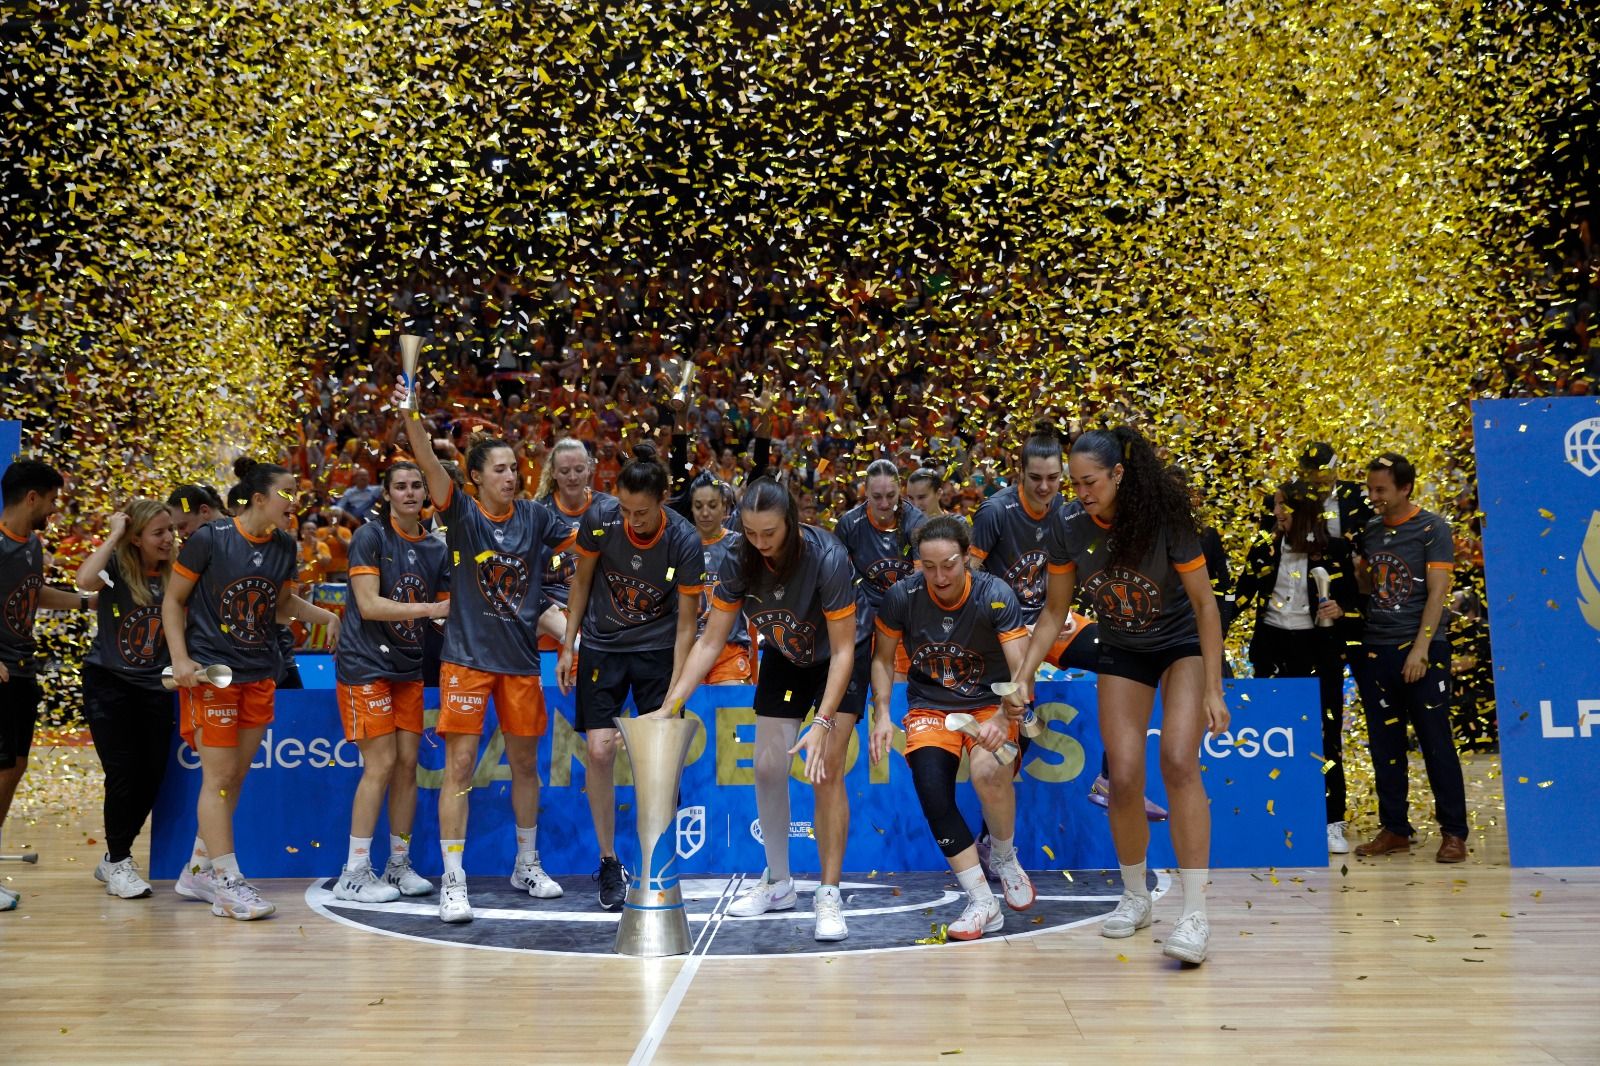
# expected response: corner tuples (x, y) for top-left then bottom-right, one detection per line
(77, 499), (176, 900)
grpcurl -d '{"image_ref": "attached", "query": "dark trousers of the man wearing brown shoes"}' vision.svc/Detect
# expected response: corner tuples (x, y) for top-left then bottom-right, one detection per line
(1352, 640), (1467, 840)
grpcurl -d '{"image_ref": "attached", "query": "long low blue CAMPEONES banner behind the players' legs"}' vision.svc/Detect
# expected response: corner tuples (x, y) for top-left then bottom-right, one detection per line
(150, 675), (1328, 877)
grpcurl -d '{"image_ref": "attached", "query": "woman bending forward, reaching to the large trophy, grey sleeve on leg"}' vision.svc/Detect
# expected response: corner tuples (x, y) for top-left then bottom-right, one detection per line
(646, 477), (859, 941)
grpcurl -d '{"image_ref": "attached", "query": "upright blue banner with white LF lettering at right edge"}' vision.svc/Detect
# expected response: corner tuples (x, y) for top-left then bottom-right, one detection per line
(1472, 397), (1600, 866)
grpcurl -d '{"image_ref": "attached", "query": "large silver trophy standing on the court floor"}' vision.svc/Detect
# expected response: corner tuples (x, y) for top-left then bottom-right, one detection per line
(614, 719), (699, 959)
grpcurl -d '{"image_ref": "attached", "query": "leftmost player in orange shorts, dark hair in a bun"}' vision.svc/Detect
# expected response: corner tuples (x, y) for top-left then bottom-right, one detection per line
(162, 463), (339, 920)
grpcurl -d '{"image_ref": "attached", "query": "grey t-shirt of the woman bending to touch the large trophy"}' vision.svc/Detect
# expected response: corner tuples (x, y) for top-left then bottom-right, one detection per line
(712, 525), (856, 666)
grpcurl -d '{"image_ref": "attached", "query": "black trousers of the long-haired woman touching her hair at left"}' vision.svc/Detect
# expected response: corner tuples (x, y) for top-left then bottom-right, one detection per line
(83, 663), (178, 863)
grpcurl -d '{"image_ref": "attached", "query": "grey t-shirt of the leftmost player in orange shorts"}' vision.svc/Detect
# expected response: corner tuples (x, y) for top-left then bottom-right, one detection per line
(173, 519), (296, 685)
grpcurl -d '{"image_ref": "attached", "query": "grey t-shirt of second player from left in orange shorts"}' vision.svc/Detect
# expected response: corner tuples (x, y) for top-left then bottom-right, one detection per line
(333, 520), (450, 685)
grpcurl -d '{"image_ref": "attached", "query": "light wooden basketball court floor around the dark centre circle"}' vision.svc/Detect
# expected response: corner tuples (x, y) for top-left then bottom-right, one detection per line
(0, 749), (1600, 1066)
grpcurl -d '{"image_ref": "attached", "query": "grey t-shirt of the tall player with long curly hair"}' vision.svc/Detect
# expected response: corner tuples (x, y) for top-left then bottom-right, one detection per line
(1046, 509), (1205, 651)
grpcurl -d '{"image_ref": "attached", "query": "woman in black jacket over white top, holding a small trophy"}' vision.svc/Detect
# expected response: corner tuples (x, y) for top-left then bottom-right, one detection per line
(1234, 479), (1358, 855)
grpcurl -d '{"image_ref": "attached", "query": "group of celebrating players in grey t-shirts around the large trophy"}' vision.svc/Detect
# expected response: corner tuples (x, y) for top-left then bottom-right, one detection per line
(0, 390), (1459, 964)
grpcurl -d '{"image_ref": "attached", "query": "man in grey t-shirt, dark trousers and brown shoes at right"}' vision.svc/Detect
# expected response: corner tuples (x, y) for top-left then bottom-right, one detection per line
(1354, 451), (1467, 863)
